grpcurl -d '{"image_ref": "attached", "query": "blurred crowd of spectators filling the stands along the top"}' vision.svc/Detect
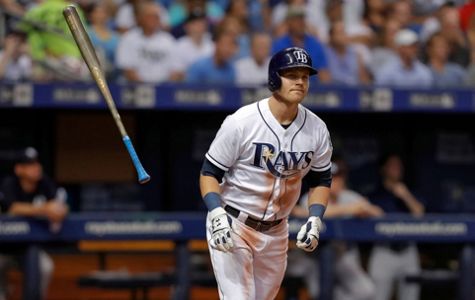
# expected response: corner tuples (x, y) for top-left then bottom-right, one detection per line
(0, 0), (475, 87)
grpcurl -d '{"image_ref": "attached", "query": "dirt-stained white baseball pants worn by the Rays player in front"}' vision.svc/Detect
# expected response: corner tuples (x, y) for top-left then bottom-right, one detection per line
(206, 213), (289, 300)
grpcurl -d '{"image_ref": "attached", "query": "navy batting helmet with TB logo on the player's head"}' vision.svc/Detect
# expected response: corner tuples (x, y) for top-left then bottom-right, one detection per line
(267, 47), (318, 92)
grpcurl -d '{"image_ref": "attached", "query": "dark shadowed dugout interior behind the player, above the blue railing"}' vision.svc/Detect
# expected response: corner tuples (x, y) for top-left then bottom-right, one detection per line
(0, 102), (475, 212)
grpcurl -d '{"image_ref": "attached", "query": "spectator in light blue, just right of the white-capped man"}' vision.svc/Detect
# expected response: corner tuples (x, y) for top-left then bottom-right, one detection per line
(427, 33), (466, 87)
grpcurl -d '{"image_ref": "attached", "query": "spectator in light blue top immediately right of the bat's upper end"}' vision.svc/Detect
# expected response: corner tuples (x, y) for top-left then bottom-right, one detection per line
(87, 2), (119, 78)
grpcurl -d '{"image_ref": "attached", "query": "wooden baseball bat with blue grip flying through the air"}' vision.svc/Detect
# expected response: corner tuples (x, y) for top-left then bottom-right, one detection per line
(63, 5), (150, 184)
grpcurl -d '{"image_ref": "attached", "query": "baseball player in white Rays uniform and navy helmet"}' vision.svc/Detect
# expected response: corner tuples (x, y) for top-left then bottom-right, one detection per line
(200, 47), (332, 300)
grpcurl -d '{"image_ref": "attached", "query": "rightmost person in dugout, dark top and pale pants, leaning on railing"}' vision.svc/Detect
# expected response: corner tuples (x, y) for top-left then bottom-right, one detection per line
(368, 154), (424, 300)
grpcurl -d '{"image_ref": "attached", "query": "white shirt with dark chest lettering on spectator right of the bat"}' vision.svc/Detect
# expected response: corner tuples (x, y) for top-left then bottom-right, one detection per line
(116, 28), (176, 83)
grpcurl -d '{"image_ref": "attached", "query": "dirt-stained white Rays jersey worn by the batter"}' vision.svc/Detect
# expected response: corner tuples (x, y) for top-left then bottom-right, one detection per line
(206, 99), (332, 221)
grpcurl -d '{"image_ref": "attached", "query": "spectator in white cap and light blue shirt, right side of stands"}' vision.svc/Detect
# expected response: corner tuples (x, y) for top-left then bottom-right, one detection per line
(375, 29), (433, 87)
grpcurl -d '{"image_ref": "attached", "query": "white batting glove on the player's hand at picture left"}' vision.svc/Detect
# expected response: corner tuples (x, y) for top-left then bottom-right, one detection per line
(209, 207), (234, 252)
